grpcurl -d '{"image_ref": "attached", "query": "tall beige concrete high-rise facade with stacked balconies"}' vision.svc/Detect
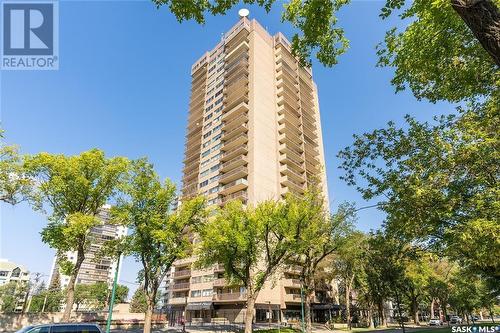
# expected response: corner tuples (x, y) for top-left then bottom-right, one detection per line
(167, 17), (334, 324)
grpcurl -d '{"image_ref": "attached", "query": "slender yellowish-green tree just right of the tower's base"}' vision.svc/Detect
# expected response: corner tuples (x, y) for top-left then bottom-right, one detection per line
(332, 231), (367, 329)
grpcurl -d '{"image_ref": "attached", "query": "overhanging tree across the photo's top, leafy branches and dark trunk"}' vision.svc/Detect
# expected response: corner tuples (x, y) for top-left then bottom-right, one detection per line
(153, 0), (500, 101)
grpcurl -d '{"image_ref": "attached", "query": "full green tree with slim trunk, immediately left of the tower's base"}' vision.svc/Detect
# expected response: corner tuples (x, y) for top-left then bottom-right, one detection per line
(112, 159), (206, 333)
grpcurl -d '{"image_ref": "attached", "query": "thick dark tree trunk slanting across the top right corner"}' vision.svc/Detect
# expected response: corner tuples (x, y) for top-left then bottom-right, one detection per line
(451, 0), (500, 66)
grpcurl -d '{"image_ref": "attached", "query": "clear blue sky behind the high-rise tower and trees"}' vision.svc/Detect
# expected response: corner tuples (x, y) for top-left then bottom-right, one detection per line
(0, 0), (453, 294)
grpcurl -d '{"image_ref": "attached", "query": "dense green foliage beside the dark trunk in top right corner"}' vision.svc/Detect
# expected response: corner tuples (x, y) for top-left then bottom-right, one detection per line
(377, 0), (500, 102)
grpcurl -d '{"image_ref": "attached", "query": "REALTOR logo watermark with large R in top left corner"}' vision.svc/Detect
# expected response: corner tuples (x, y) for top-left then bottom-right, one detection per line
(1, 0), (59, 70)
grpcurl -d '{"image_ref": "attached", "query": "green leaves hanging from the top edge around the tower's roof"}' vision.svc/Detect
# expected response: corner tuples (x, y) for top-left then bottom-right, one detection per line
(153, 0), (350, 67)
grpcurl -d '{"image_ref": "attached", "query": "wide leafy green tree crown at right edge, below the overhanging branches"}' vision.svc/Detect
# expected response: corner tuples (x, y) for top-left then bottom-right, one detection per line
(338, 98), (500, 288)
